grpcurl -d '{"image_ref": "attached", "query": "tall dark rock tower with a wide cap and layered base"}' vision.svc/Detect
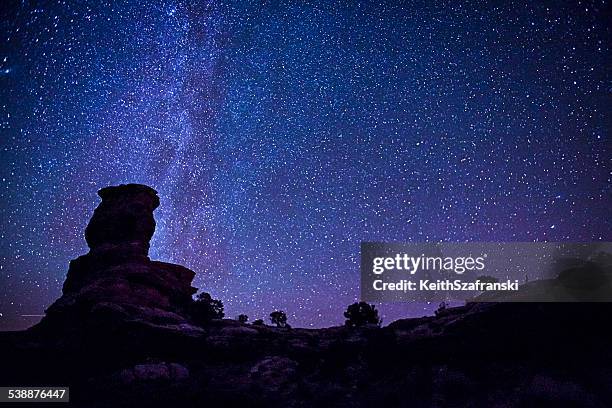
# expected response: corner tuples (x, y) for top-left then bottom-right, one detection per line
(41, 184), (196, 329)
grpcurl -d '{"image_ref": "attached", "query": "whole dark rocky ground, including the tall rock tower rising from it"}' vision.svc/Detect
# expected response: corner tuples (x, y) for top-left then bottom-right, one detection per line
(0, 185), (612, 408)
